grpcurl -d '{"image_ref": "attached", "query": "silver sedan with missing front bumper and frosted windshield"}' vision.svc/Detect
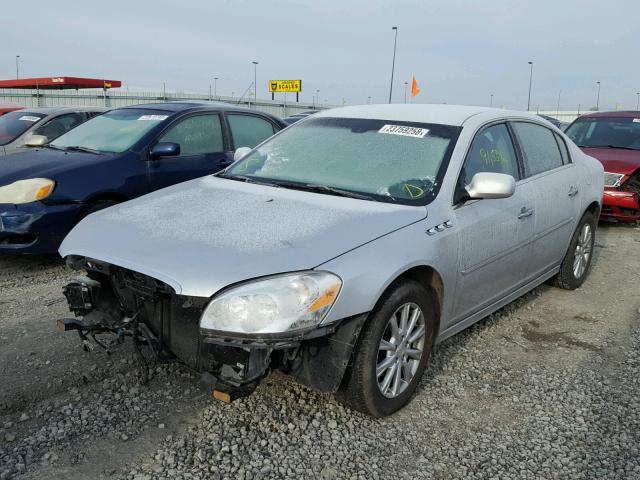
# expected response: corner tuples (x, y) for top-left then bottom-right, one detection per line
(60, 105), (603, 416)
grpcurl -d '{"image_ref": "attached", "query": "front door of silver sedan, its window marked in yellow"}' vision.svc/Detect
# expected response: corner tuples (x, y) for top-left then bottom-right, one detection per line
(452, 123), (534, 323)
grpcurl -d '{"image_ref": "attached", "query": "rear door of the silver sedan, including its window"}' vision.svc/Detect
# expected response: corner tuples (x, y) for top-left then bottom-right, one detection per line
(510, 121), (581, 275)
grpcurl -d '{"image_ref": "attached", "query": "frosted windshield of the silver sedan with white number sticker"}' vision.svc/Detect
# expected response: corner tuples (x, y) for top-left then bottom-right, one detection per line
(222, 117), (460, 205)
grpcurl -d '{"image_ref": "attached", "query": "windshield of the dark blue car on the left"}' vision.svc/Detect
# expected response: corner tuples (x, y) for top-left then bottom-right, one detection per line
(51, 108), (171, 153)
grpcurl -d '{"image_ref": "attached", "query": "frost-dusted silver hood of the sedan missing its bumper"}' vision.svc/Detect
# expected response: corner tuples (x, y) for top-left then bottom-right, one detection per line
(60, 176), (427, 297)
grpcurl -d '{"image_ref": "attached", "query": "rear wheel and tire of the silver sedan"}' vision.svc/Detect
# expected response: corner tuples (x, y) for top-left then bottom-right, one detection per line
(553, 212), (596, 290)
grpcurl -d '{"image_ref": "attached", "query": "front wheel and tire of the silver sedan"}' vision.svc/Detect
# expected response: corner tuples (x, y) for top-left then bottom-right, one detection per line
(336, 280), (436, 417)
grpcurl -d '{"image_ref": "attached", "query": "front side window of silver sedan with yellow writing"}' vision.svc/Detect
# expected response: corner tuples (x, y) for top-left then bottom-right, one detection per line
(458, 123), (520, 187)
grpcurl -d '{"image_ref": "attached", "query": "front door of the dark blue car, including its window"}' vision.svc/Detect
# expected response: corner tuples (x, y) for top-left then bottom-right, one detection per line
(148, 113), (232, 190)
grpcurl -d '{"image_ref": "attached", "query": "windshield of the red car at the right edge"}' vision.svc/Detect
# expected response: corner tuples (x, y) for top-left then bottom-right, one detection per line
(565, 114), (640, 150)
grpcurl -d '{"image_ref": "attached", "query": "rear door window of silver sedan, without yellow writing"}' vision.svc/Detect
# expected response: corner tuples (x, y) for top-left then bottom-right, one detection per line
(513, 122), (563, 177)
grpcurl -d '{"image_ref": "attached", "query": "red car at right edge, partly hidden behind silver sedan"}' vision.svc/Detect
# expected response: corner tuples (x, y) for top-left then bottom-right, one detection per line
(565, 112), (640, 222)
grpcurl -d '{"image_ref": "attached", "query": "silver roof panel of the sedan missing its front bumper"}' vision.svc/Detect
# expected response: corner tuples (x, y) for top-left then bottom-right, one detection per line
(314, 104), (540, 126)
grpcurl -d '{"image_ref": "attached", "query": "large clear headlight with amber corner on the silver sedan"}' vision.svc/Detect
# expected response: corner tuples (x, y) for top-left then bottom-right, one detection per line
(200, 272), (342, 333)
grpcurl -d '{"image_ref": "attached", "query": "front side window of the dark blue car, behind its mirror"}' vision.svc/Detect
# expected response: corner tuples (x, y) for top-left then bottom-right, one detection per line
(158, 114), (224, 157)
